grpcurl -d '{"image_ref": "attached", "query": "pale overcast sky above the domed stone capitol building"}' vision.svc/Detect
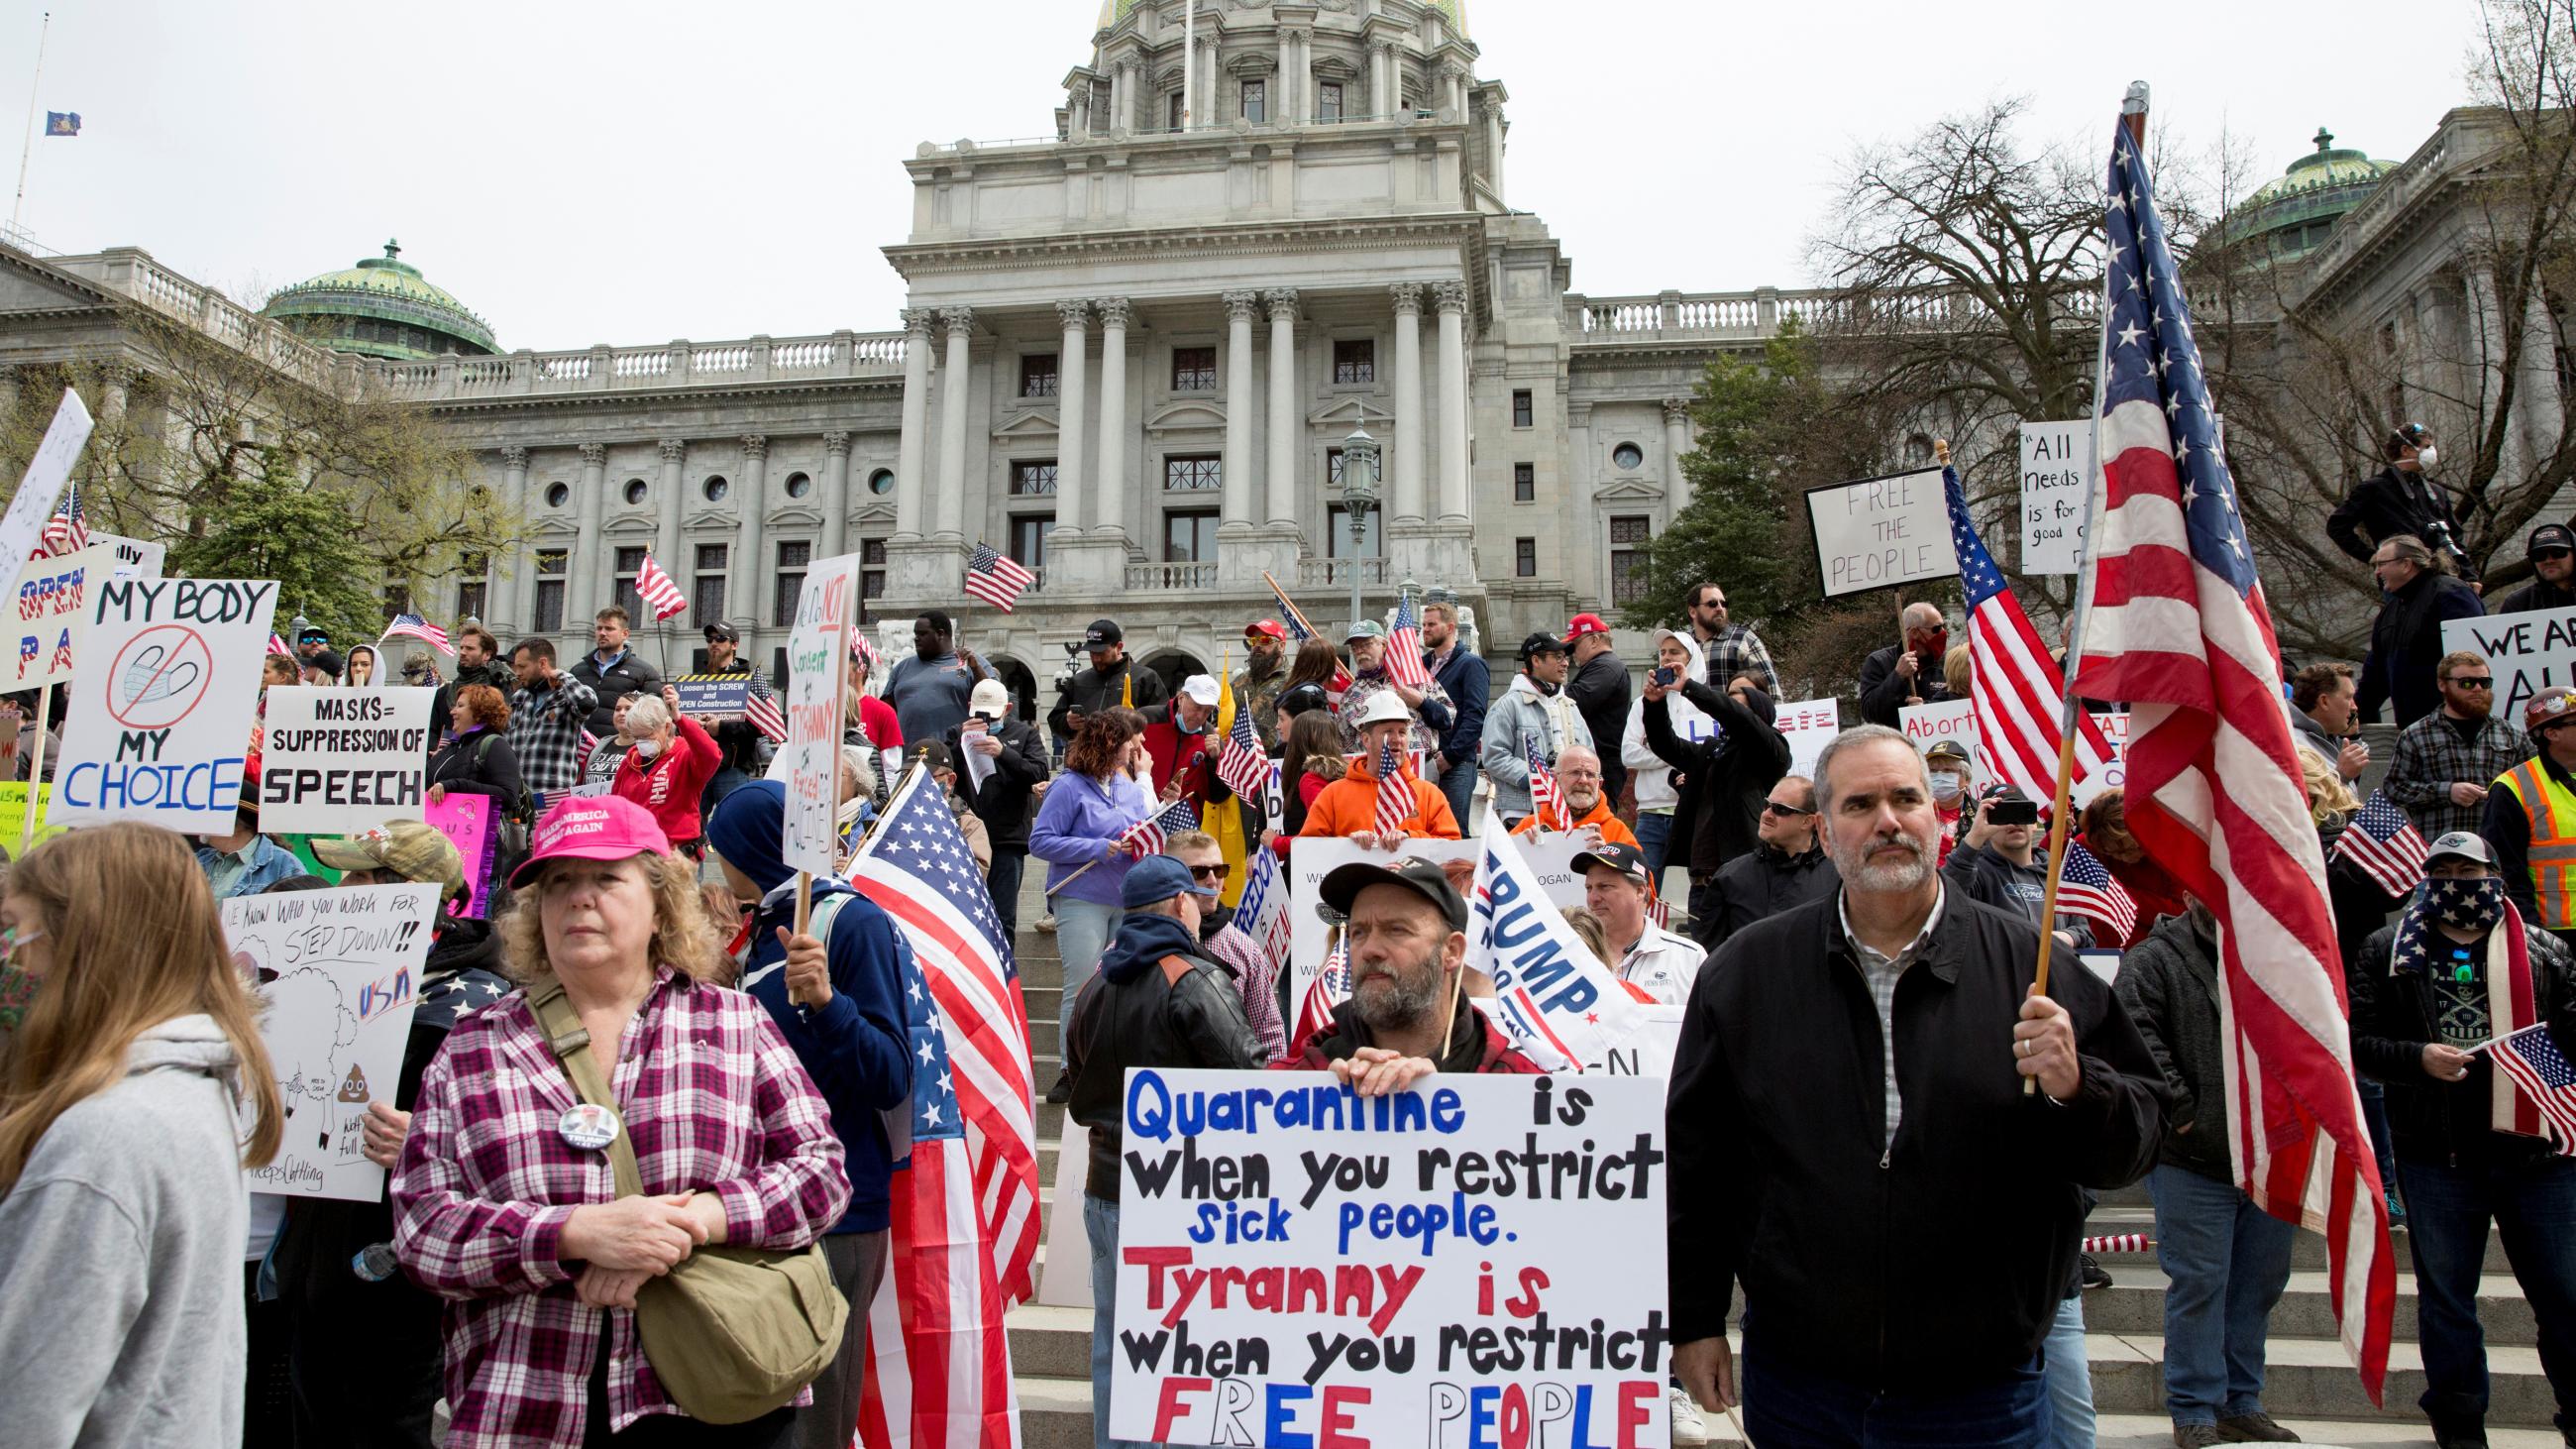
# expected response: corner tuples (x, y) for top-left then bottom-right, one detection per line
(0, 0), (2476, 348)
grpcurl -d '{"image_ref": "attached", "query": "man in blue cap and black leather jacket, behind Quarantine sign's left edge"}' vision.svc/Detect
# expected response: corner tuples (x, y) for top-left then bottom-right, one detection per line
(1064, 856), (1262, 1446)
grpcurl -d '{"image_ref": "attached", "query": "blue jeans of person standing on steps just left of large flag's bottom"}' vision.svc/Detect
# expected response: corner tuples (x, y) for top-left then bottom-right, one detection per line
(2146, 1163), (2298, 1426)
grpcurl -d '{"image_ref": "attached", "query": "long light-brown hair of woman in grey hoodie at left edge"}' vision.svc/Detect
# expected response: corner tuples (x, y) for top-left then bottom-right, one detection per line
(0, 820), (286, 1196)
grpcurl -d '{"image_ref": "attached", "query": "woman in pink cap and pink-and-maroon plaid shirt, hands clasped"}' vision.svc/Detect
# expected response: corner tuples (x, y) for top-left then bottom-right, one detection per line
(394, 797), (850, 1449)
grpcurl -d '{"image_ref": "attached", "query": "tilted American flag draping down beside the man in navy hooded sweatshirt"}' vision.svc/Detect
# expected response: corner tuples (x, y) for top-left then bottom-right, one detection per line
(850, 768), (1040, 1302)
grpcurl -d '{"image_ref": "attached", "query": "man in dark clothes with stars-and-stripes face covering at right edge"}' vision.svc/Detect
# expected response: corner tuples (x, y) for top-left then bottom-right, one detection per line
(2359, 831), (2576, 1449)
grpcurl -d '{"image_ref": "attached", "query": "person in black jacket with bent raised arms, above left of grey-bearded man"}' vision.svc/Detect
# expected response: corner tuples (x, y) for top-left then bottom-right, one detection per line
(1646, 676), (1787, 938)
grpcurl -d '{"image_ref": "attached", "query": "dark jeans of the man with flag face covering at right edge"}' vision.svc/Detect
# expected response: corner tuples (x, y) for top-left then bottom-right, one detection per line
(2399, 1153), (2576, 1431)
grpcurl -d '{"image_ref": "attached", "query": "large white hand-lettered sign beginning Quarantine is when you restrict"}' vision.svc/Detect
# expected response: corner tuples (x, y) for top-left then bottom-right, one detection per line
(1111, 1067), (1671, 1449)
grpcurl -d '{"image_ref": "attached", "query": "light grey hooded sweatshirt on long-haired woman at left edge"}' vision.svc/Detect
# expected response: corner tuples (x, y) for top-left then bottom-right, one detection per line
(0, 1016), (250, 1449)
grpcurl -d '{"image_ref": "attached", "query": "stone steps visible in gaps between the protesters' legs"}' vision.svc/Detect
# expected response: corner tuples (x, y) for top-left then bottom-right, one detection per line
(984, 871), (2560, 1449)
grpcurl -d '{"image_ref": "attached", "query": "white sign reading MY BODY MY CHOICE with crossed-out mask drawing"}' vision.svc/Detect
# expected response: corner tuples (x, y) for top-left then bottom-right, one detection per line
(54, 578), (278, 833)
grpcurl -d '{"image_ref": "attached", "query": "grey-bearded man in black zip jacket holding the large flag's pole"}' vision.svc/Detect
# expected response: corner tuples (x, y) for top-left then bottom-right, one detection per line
(1664, 724), (2159, 1449)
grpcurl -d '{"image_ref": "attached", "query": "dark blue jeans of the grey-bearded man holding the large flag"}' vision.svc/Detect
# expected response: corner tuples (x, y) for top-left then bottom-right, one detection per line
(1744, 1323), (2050, 1449)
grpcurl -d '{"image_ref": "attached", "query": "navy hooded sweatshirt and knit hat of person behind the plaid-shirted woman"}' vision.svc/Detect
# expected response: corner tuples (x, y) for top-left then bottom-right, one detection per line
(705, 779), (912, 1232)
